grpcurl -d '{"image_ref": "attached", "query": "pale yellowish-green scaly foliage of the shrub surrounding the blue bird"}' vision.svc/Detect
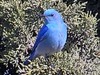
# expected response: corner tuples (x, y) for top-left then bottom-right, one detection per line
(0, 0), (100, 75)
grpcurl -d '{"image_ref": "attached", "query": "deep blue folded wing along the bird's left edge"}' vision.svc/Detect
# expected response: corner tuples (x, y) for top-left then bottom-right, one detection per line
(33, 25), (48, 50)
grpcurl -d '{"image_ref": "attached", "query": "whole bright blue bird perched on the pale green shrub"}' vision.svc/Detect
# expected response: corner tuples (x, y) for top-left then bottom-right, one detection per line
(24, 9), (67, 65)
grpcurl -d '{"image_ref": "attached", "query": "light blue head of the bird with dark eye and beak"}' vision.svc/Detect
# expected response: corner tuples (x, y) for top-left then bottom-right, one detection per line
(43, 9), (63, 23)
